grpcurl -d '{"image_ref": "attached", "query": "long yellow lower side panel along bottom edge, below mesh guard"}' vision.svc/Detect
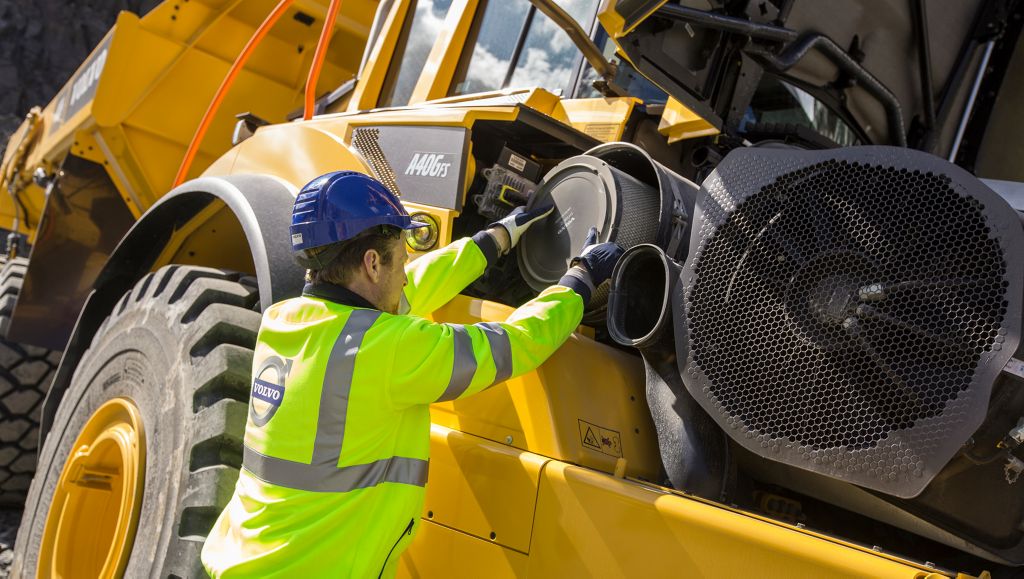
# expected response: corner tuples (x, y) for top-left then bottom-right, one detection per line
(529, 462), (934, 579)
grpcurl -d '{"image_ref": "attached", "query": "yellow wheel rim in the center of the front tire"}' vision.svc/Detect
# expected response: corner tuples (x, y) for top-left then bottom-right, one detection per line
(38, 398), (145, 577)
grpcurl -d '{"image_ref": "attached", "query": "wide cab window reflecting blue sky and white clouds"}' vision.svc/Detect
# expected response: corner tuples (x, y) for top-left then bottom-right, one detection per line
(449, 0), (597, 95)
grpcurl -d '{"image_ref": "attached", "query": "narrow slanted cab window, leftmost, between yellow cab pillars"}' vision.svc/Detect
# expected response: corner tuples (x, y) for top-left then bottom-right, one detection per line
(377, 0), (452, 107)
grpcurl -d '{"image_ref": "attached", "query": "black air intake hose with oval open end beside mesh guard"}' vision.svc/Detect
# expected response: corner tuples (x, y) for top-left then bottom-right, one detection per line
(607, 244), (729, 500)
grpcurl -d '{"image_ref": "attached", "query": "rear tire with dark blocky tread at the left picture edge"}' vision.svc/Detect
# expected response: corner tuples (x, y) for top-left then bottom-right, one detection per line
(0, 257), (60, 507)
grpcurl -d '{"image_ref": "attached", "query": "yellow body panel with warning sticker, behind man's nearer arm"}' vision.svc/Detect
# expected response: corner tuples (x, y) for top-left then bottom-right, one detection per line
(431, 296), (662, 481)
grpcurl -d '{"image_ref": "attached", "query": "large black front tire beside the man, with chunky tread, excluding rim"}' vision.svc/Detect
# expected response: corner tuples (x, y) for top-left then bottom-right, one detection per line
(13, 265), (260, 578)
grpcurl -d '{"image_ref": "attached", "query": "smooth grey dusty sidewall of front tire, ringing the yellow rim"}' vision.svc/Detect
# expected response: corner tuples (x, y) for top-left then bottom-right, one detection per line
(14, 296), (191, 577)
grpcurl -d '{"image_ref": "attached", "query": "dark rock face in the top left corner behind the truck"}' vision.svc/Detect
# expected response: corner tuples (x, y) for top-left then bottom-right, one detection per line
(0, 0), (160, 145)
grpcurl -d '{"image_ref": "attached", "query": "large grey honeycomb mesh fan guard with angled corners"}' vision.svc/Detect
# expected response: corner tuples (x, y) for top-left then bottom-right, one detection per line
(677, 148), (1020, 496)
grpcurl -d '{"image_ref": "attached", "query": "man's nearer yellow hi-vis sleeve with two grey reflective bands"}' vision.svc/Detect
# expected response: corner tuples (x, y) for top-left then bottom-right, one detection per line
(388, 286), (587, 408)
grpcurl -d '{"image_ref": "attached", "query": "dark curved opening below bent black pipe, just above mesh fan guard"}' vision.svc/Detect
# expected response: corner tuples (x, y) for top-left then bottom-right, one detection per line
(739, 76), (861, 147)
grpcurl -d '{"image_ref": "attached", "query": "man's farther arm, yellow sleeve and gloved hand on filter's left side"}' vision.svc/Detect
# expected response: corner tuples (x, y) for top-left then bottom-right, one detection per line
(398, 207), (552, 316)
